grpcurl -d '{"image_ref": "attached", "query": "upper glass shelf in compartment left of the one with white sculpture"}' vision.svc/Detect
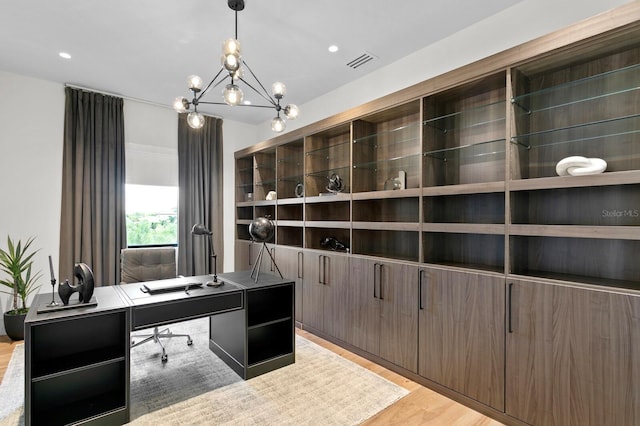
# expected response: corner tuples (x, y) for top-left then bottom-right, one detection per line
(422, 100), (506, 133)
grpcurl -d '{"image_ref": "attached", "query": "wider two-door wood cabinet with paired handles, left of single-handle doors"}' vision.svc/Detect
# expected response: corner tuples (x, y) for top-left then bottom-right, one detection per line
(346, 257), (419, 373)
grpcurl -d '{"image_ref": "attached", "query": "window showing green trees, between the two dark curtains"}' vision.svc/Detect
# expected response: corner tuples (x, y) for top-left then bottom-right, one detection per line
(125, 184), (178, 247)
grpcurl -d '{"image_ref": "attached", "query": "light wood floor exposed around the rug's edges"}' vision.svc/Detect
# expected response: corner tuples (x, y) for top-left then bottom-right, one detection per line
(0, 329), (502, 426)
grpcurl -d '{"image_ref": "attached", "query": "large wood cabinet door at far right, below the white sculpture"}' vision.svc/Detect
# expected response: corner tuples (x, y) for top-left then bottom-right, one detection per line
(506, 281), (640, 425)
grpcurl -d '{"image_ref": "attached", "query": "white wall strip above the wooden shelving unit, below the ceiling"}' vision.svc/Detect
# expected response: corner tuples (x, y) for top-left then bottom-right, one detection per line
(257, 0), (631, 141)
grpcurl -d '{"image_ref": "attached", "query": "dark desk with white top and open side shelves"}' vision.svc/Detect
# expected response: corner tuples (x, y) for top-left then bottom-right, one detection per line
(25, 272), (295, 425)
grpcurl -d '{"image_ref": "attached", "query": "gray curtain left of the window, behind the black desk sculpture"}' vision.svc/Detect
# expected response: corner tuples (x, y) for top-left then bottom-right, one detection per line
(59, 87), (126, 286)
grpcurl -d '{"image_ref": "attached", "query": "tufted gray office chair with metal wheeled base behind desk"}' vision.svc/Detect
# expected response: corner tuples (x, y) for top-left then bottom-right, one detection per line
(120, 247), (193, 362)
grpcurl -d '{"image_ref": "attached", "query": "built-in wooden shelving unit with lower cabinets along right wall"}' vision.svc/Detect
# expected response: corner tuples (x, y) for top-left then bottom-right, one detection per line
(236, 3), (640, 424)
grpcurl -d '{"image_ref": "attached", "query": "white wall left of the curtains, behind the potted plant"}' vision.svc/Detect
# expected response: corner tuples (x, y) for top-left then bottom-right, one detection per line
(0, 71), (64, 334)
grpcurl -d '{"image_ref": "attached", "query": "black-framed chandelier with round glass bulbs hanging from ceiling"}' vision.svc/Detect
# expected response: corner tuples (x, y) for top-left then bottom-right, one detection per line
(173, 0), (299, 132)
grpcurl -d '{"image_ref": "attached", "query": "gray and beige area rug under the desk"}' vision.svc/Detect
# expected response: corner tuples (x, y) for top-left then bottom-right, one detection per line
(0, 319), (408, 426)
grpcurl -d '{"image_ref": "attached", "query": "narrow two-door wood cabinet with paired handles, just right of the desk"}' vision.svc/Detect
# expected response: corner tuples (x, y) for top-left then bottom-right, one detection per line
(302, 250), (349, 340)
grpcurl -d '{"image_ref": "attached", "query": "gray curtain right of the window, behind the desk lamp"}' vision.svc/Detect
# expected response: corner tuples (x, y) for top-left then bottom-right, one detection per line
(178, 114), (224, 276)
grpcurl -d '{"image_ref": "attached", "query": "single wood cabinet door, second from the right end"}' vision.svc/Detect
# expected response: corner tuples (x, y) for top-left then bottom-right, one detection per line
(419, 269), (505, 410)
